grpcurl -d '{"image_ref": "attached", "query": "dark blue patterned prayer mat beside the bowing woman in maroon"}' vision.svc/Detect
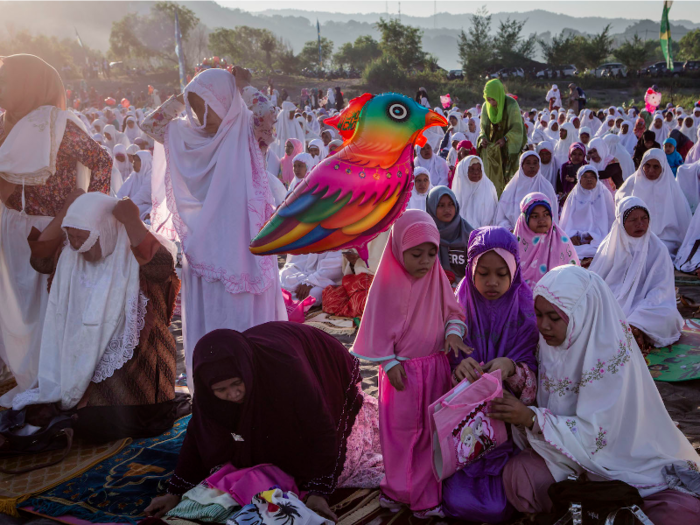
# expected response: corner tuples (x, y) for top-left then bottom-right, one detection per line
(22, 416), (191, 524)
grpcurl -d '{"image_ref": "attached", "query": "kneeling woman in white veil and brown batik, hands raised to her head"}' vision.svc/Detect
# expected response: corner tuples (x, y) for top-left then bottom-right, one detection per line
(21, 190), (180, 440)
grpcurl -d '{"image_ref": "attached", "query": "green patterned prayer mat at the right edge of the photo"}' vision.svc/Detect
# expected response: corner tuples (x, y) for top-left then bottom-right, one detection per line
(646, 319), (700, 382)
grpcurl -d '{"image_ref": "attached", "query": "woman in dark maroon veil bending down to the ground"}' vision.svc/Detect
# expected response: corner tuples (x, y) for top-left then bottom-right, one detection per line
(146, 322), (384, 519)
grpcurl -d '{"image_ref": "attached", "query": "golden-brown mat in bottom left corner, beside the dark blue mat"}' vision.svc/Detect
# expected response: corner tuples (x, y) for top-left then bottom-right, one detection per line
(0, 439), (131, 516)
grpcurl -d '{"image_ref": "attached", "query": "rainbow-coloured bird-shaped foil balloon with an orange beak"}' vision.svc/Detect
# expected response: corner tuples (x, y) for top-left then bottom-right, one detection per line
(250, 93), (447, 255)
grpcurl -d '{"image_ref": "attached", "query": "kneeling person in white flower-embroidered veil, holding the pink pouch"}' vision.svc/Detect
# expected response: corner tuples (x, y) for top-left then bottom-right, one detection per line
(491, 266), (700, 525)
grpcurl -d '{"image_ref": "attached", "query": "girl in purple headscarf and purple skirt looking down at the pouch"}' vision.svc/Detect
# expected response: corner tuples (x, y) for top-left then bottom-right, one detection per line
(443, 226), (539, 523)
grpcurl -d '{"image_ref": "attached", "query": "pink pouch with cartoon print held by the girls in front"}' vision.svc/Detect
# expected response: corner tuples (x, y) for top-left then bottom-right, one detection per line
(429, 370), (508, 481)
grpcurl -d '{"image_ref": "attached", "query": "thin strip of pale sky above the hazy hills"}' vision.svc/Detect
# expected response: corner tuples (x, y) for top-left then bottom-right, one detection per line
(215, 0), (700, 23)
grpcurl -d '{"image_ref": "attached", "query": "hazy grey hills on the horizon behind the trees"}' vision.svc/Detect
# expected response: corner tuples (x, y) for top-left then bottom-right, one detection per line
(0, 0), (700, 69)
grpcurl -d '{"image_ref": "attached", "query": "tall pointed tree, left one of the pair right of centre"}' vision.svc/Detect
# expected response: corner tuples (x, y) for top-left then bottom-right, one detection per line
(458, 7), (495, 81)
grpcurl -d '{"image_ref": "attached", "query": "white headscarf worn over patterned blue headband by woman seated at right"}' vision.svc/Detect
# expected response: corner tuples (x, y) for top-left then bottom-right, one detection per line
(590, 197), (683, 347)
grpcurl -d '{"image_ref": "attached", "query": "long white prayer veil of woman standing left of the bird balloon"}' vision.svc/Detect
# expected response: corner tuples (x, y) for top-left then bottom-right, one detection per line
(165, 69), (274, 295)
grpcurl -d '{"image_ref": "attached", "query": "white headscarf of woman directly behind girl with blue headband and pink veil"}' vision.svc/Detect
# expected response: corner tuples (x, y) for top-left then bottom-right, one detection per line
(495, 151), (559, 231)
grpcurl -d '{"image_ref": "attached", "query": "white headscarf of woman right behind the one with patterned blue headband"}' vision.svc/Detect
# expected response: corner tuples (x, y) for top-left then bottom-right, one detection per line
(615, 148), (692, 256)
